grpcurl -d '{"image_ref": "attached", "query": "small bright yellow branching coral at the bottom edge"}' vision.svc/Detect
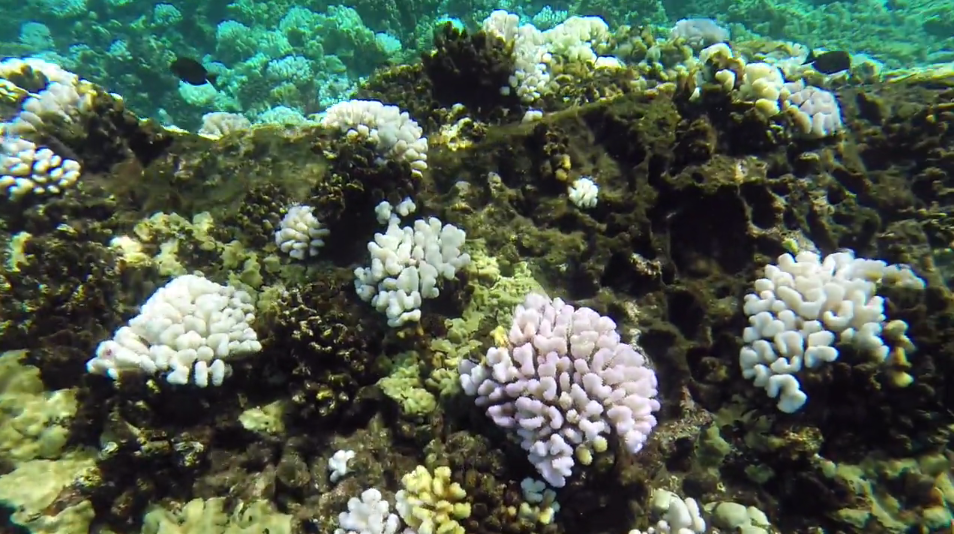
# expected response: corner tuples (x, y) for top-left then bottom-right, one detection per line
(396, 465), (470, 534)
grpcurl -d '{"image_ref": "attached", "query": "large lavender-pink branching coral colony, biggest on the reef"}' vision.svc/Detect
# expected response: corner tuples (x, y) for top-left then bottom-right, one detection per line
(460, 294), (659, 487)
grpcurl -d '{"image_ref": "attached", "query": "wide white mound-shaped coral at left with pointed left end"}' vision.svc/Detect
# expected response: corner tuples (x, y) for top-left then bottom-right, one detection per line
(86, 275), (262, 387)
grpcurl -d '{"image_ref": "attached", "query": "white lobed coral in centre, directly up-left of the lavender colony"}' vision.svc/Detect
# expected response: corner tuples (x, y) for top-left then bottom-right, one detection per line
(354, 202), (470, 326)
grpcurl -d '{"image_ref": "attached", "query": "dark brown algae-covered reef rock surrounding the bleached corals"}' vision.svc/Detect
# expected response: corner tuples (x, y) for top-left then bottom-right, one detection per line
(0, 29), (954, 534)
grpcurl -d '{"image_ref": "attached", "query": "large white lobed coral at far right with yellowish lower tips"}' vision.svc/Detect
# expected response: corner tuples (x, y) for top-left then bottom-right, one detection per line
(739, 251), (924, 413)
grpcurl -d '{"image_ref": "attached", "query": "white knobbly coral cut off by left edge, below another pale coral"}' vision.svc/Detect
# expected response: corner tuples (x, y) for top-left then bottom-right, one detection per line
(0, 137), (82, 200)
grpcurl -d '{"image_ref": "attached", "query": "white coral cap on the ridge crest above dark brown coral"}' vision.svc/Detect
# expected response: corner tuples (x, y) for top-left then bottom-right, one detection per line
(321, 100), (427, 181)
